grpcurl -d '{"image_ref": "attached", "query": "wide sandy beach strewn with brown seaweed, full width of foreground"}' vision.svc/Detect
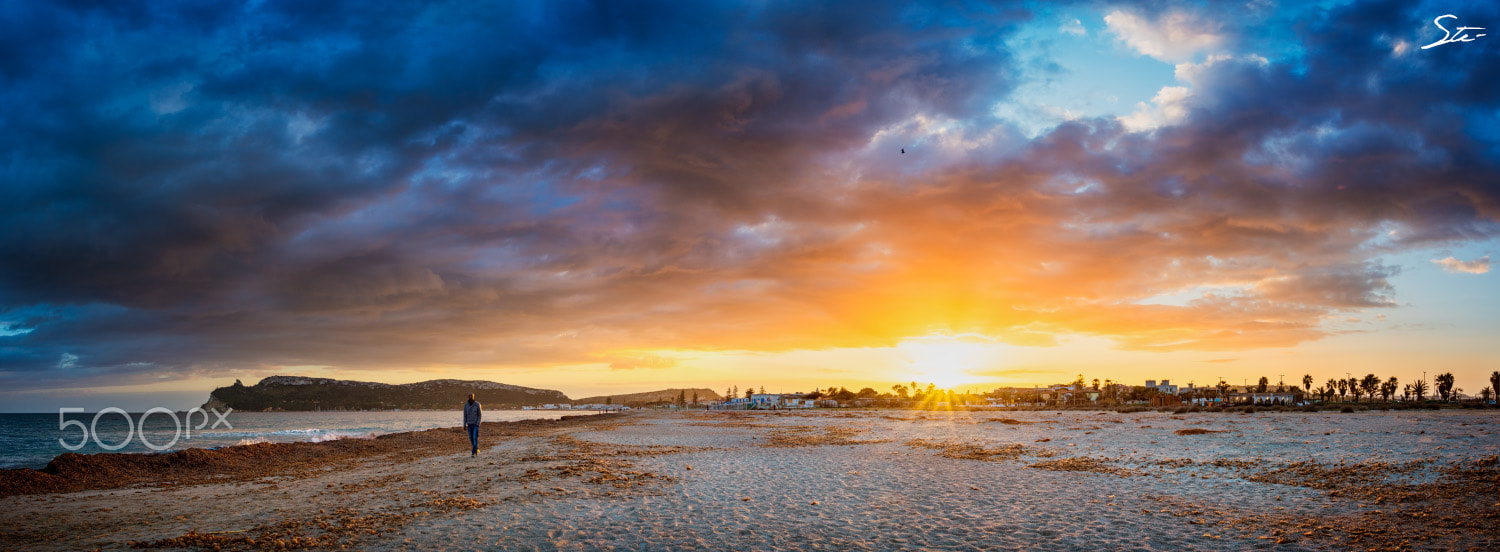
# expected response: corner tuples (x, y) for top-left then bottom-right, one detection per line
(0, 411), (1500, 551)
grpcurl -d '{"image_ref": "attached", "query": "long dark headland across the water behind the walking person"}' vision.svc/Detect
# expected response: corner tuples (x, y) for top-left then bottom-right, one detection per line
(203, 375), (570, 411)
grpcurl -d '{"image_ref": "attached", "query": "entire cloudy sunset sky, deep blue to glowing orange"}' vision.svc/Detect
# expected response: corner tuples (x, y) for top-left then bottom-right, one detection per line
(0, 0), (1500, 413)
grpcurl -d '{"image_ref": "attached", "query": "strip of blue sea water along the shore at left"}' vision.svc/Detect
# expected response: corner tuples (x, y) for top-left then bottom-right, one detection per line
(0, 410), (590, 468)
